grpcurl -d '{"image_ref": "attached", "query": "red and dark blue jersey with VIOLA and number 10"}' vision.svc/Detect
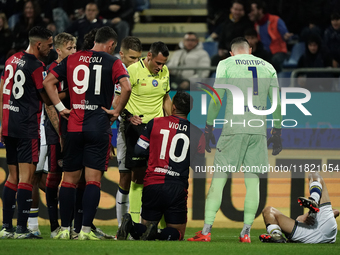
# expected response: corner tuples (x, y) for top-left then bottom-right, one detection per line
(137, 115), (205, 188)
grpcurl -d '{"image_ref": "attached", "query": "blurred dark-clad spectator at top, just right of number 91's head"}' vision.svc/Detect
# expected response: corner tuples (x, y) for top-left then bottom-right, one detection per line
(97, 0), (135, 53)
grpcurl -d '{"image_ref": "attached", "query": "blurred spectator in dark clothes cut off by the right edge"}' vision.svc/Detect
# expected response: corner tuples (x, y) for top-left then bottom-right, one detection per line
(324, 13), (340, 67)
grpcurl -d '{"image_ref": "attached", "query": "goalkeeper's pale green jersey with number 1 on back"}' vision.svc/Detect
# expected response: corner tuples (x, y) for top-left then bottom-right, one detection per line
(215, 54), (281, 135)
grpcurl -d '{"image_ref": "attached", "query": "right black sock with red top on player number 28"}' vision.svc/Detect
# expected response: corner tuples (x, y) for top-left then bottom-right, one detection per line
(17, 183), (33, 233)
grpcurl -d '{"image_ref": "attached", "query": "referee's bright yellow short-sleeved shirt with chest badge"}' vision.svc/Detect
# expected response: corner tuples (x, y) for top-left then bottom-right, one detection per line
(125, 59), (170, 124)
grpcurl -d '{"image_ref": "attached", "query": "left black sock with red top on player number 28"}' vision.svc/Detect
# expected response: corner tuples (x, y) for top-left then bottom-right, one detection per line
(2, 181), (17, 229)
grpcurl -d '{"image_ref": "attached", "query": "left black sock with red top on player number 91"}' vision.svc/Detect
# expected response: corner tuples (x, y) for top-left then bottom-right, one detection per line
(59, 182), (76, 227)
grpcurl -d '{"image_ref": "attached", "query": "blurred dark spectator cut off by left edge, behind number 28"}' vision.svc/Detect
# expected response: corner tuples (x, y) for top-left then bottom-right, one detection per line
(0, 13), (13, 65)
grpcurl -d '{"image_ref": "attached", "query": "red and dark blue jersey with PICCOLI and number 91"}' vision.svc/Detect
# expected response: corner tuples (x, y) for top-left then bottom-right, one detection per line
(51, 50), (129, 133)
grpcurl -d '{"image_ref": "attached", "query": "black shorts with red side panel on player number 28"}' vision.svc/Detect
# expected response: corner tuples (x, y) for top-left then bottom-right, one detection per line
(4, 136), (39, 165)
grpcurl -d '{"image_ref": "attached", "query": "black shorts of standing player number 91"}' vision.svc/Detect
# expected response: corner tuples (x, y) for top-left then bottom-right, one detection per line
(63, 131), (112, 172)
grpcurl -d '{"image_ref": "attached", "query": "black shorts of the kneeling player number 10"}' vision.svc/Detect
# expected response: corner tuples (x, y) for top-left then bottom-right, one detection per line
(142, 184), (188, 224)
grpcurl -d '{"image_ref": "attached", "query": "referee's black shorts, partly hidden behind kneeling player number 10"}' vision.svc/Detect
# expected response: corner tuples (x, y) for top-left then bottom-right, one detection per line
(125, 123), (147, 168)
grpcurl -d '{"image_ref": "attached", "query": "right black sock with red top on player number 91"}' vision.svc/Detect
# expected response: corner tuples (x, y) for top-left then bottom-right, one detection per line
(83, 181), (100, 227)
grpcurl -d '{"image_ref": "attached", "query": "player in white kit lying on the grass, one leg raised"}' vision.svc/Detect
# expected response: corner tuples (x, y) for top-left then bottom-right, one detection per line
(259, 173), (339, 243)
